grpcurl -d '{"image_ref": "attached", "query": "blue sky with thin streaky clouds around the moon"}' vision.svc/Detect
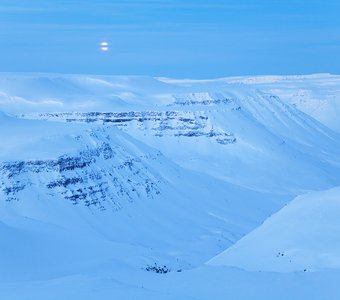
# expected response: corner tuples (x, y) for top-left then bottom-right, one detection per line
(0, 0), (340, 78)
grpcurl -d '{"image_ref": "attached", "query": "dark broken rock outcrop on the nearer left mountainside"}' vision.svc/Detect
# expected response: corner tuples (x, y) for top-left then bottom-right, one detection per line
(0, 129), (163, 210)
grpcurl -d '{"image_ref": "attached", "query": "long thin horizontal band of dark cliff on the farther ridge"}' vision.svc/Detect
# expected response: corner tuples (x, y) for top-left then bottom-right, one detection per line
(22, 111), (236, 145)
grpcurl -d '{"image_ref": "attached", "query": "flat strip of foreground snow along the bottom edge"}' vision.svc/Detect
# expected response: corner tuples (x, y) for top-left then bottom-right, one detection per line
(0, 265), (340, 300)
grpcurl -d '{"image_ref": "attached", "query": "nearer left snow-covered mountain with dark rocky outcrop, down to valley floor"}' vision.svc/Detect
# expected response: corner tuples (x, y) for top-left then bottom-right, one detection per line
(0, 110), (288, 279)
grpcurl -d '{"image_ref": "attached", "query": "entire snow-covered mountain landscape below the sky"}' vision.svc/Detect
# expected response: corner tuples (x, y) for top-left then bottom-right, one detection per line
(0, 73), (340, 300)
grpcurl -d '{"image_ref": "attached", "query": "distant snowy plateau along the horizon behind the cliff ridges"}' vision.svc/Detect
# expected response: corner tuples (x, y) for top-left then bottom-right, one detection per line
(0, 73), (340, 131)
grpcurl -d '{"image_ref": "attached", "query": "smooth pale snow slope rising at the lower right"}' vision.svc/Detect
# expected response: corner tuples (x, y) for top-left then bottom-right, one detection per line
(208, 188), (340, 272)
